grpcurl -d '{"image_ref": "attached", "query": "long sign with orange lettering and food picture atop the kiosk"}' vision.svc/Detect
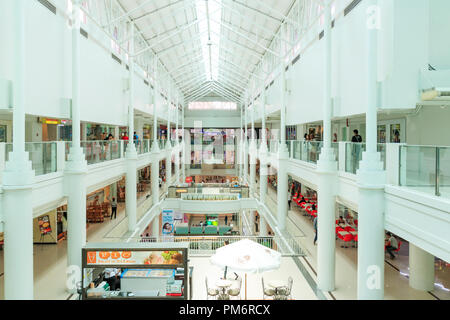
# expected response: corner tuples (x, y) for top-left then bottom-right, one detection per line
(86, 251), (183, 266)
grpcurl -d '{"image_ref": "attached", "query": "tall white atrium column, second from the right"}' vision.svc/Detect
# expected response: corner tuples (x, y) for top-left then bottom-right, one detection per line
(317, 0), (337, 291)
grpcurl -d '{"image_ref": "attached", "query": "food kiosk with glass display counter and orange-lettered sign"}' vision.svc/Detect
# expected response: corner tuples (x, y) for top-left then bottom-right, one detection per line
(82, 242), (192, 300)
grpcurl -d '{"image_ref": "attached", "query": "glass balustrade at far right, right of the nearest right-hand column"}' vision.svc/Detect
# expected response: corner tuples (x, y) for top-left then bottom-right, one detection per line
(399, 145), (450, 198)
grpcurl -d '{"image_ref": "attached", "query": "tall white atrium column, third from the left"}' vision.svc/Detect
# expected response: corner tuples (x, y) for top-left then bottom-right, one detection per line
(125, 23), (137, 231)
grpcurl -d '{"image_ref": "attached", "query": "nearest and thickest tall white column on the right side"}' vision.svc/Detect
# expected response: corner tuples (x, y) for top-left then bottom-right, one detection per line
(357, 0), (385, 300)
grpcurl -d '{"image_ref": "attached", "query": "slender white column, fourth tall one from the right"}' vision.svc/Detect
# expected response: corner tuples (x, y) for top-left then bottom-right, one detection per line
(259, 82), (269, 204)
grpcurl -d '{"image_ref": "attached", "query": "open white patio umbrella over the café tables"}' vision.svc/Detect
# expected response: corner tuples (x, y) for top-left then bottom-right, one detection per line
(210, 239), (281, 299)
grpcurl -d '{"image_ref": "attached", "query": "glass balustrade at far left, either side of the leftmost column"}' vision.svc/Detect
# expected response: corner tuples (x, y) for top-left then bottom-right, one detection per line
(5, 142), (57, 176)
